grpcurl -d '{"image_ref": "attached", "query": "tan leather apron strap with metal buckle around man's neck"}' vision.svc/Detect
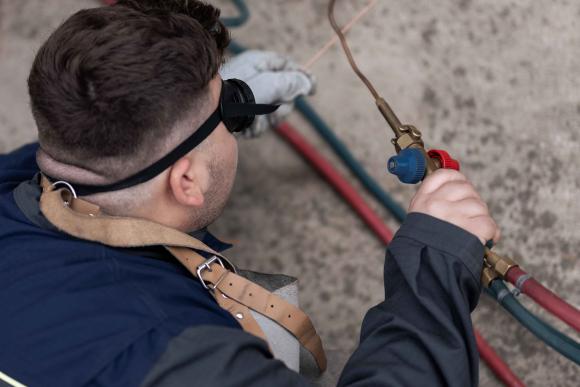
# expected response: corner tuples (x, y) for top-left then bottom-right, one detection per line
(40, 176), (326, 371)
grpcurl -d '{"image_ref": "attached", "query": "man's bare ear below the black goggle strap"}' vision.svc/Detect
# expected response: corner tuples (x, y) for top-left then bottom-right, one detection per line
(169, 157), (205, 207)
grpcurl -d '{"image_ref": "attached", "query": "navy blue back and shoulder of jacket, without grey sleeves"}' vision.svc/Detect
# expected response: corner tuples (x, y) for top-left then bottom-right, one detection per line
(0, 145), (239, 386)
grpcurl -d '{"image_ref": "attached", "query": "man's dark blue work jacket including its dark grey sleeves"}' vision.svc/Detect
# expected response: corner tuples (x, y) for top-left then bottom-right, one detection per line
(0, 145), (483, 387)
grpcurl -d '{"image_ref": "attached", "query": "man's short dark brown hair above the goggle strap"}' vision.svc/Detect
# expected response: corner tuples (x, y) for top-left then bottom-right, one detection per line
(28, 0), (229, 175)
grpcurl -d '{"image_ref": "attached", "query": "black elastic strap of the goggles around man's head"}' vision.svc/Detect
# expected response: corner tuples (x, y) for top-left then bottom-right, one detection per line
(47, 91), (278, 196)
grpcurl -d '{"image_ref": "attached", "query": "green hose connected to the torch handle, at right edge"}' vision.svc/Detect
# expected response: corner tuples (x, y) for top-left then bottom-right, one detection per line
(486, 280), (580, 365)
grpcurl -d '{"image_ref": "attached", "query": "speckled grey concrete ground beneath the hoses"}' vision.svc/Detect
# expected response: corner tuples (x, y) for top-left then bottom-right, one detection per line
(0, 0), (580, 386)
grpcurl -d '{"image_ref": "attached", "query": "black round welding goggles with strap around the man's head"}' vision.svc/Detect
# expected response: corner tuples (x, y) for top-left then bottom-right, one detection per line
(54, 79), (278, 196)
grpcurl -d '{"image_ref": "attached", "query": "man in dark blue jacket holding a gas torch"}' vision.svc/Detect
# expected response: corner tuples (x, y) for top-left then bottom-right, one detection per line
(0, 0), (499, 386)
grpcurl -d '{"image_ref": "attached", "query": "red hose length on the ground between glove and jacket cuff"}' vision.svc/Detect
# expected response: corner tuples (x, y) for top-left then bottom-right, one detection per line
(276, 122), (393, 244)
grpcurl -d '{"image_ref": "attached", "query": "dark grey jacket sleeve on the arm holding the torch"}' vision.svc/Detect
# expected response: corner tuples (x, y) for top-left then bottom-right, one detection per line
(339, 213), (483, 387)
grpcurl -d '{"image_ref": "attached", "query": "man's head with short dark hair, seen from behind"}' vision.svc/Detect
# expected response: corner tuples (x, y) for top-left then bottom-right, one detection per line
(29, 0), (237, 229)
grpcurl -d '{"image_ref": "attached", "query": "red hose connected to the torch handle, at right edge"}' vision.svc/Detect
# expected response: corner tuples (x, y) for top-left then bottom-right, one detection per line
(506, 266), (580, 332)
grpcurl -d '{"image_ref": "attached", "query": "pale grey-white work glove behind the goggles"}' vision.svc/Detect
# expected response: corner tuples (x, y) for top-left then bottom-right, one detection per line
(219, 50), (315, 137)
